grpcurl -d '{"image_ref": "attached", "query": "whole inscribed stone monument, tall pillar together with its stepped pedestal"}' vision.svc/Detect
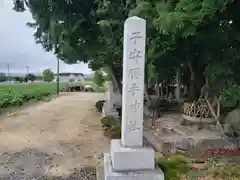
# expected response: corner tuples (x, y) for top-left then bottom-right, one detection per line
(104, 17), (164, 180)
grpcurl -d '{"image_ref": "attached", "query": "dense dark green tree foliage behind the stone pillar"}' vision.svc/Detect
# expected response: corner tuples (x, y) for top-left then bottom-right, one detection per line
(12, 0), (240, 105)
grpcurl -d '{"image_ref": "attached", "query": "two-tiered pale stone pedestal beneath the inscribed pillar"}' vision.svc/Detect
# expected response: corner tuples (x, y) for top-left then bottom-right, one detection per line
(104, 139), (164, 180)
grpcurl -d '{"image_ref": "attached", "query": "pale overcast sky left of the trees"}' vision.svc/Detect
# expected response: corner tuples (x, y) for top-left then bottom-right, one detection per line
(0, 0), (91, 74)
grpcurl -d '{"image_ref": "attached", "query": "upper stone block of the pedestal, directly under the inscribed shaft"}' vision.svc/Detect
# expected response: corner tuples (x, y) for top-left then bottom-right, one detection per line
(110, 139), (155, 171)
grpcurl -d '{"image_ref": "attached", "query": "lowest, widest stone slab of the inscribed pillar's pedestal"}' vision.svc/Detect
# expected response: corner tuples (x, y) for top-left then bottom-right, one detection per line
(104, 154), (164, 180)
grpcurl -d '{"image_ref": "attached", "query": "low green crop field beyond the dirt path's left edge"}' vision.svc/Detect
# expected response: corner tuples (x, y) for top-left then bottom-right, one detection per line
(0, 81), (104, 108)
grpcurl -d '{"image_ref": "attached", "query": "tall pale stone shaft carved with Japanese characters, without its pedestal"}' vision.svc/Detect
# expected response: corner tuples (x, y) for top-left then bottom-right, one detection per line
(121, 17), (146, 147)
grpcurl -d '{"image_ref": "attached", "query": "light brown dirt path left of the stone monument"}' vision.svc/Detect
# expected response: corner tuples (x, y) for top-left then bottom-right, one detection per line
(0, 92), (109, 176)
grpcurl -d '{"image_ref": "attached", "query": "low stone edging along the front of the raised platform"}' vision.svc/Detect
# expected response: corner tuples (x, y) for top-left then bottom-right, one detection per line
(144, 131), (240, 156)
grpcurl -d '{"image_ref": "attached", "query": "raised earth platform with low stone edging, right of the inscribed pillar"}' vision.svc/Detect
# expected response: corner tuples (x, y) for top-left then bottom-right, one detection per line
(144, 114), (240, 156)
